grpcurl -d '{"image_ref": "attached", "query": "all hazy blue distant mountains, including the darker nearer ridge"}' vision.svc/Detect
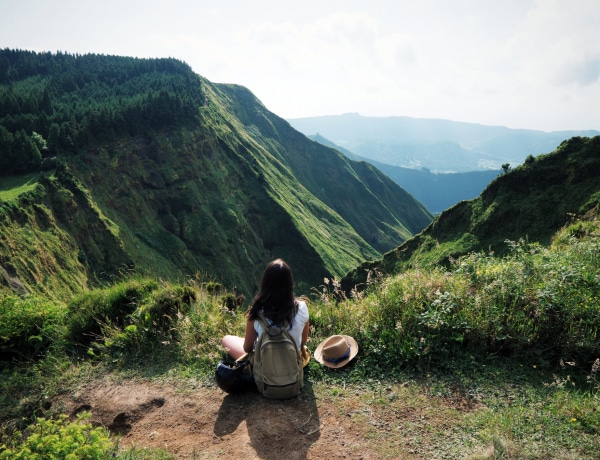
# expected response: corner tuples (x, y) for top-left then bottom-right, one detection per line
(288, 113), (600, 214)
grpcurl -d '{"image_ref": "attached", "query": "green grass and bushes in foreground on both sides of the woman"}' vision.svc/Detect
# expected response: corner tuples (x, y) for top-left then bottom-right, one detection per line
(0, 218), (600, 458)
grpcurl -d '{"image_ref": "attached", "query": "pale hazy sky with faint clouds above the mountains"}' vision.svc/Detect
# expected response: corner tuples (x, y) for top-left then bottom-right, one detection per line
(0, 0), (600, 131)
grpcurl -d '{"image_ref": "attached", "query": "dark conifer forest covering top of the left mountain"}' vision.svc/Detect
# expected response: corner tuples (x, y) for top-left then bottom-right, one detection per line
(0, 49), (203, 175)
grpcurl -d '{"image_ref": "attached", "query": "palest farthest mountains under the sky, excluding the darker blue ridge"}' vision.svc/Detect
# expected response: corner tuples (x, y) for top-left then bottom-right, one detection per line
(288, 113), (600, 173)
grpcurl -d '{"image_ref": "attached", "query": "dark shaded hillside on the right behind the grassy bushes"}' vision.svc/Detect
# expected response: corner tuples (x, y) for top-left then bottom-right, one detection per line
(343, 136), (600, 289)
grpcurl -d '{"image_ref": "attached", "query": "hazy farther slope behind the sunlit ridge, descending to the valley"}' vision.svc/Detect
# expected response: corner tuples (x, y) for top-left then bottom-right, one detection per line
(204, 84), (431, 251)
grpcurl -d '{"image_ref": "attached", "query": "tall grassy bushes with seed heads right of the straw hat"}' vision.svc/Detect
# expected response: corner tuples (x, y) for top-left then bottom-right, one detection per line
(310, 221), (600, 371)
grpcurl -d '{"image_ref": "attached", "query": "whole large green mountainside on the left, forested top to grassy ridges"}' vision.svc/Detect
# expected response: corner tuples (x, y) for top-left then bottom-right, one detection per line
(0, 50), (432, 294)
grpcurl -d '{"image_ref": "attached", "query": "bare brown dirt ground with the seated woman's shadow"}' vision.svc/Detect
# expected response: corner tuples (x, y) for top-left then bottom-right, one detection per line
(53, 382), (480, 460)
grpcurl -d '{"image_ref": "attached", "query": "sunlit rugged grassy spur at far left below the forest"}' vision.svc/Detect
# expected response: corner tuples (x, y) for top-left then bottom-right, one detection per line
(0, 166), (131, 297)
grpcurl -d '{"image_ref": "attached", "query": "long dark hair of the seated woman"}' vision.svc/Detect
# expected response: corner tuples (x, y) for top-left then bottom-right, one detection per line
(248, 259), (298, 326)
